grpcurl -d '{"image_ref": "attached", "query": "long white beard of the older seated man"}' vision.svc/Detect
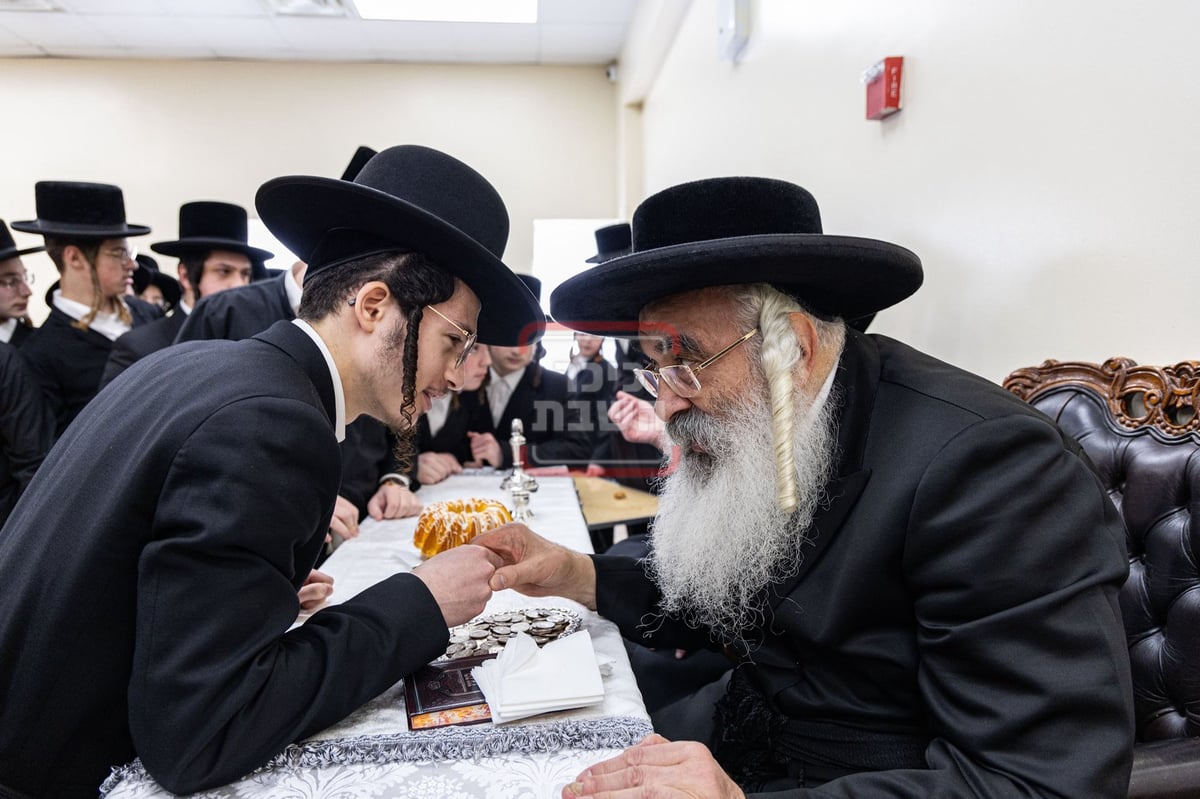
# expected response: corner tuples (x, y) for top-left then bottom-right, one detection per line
(648, 376), (839, 642)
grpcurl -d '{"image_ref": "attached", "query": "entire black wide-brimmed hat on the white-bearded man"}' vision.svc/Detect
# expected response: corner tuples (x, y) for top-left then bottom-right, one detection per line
(550, 178), (923, 336)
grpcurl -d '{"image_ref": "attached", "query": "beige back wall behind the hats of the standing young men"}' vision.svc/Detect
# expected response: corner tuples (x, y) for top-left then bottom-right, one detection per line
(0, 60), (617, 320)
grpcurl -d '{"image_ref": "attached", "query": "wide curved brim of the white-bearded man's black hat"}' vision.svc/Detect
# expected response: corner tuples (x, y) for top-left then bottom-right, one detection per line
(550, 234), (923, 336)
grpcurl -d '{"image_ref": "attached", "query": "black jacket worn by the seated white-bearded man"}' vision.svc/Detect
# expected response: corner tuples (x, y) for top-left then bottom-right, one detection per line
(595, 331), (1133, 799)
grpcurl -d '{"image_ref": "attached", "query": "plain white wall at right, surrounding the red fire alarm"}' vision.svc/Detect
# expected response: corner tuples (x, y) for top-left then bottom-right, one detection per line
(629, 0), (1200, 380)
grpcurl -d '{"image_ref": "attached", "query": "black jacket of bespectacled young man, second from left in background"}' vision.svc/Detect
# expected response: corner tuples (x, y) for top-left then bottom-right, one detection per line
(20, 296), (162, 437)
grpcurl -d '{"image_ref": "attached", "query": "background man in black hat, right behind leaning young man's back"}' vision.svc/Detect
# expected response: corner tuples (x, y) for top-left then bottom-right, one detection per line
(101, 202), (275, 386)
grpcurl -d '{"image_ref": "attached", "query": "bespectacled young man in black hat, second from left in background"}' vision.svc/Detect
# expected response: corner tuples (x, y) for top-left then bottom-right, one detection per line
(12, 181), (162, 435)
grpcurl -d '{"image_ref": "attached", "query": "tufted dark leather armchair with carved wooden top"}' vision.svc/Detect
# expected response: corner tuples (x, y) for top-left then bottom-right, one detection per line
(1004, 358), (1200, 799)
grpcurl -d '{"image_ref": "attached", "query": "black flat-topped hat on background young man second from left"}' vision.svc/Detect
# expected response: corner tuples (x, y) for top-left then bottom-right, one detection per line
(12, 180), (150, 239)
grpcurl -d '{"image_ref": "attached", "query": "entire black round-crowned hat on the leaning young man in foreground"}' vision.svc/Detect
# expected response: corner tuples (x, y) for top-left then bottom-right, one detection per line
(254, 144), (544, 346)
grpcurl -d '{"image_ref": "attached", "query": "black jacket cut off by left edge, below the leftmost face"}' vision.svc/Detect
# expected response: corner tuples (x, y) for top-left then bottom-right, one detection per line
(0, 343), (54, 525)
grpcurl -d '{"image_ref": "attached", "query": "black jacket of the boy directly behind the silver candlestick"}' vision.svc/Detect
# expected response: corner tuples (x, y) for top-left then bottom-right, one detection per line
(463, 362), (592, 469)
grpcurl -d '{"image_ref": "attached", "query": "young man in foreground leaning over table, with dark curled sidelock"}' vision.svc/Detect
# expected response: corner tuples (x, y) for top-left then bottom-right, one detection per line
(0, 146), (541, 797)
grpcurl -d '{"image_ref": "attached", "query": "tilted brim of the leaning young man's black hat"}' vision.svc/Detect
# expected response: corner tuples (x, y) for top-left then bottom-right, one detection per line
(264, 175), (544, 346)
